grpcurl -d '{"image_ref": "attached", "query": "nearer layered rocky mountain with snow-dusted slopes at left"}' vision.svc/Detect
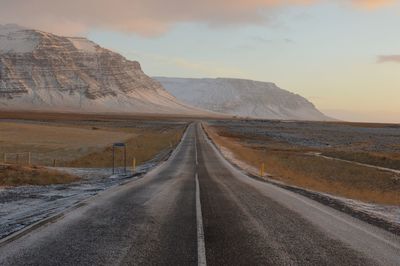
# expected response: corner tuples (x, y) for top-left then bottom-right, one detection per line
(0, 24), (206, 114)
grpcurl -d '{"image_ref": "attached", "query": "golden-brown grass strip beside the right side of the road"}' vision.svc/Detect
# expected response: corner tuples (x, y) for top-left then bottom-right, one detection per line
(206, 123), (400, 205)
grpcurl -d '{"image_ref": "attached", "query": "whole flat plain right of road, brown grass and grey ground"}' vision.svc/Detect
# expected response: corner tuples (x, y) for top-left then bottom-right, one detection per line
(208, 120), (400, 205)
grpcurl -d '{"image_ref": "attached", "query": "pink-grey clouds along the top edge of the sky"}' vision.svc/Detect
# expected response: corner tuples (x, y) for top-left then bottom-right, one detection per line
(0, 0), (390, 36)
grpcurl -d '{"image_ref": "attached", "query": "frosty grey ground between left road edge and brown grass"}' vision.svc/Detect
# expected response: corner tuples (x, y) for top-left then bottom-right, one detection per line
(0, 150), (170, 239)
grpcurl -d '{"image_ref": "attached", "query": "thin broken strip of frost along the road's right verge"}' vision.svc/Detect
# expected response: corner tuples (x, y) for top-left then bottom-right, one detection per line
(218, 141), (400, 227)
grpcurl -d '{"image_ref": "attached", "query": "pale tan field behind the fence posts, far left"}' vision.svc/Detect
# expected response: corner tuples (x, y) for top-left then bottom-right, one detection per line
(0, 122), (135, 165)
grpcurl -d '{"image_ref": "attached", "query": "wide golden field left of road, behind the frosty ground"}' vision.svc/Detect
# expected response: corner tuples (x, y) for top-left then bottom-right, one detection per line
(0, 121), (185, 167)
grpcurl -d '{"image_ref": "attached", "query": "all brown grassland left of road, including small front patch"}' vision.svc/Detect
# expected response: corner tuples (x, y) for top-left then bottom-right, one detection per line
(0, 116), (186, 186)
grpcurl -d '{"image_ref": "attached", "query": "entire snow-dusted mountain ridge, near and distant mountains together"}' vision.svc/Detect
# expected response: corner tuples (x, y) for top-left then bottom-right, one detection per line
(0, 24), (332, 120)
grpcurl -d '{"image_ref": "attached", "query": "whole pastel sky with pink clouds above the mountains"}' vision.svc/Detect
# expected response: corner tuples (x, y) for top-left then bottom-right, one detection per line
(0, 0), (400, 123)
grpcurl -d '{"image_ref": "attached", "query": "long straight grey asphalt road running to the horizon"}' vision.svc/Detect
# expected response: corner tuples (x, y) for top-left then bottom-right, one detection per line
(0, 125), (400, 265)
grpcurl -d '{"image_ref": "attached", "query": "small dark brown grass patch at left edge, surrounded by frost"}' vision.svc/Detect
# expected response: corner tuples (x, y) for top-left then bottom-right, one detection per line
(0, 165), (79, 187)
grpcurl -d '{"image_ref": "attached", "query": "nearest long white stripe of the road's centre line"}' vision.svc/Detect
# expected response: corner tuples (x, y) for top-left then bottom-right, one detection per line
(196, 173), (207, 266)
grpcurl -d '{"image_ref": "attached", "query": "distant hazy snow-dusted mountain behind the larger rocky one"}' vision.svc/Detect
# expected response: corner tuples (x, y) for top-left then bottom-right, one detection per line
(155, 77), (332, 120)
